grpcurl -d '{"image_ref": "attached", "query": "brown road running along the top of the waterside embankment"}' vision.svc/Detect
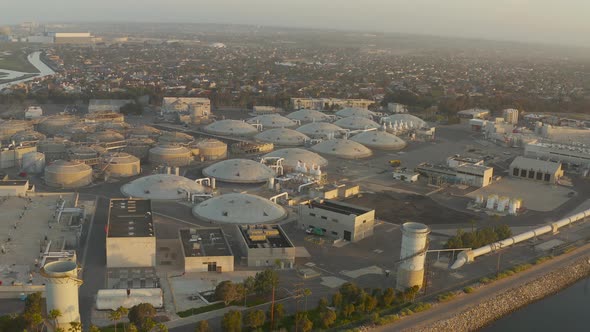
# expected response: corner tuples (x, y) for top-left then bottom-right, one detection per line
(372, 244), (590, 331)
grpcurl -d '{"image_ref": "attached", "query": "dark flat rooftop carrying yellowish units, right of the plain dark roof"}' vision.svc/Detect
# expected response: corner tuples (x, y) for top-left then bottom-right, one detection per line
(238, 225), (293, 249)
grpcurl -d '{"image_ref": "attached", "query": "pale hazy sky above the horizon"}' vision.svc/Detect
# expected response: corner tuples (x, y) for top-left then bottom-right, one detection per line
(0, 0), (590, 47)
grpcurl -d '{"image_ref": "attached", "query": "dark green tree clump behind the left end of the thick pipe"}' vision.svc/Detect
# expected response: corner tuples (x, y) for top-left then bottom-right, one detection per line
(445, 225), (512, 249)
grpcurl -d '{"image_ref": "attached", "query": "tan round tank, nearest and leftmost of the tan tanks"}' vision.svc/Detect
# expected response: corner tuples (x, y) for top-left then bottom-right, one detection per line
(45, 160), (92, 189)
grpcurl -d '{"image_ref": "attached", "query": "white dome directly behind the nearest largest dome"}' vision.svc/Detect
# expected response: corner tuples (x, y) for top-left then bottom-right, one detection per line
(203, 159), (276, 183)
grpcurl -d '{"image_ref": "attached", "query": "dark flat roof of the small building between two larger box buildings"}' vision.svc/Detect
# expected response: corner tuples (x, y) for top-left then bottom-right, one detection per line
(179, 228), (234, 257)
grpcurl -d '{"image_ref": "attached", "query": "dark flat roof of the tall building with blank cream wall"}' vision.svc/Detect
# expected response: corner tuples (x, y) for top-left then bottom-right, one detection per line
(107, 198), (154, 237)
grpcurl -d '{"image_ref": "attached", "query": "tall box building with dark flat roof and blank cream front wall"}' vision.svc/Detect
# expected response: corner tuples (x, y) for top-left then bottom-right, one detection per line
(106, 198), (156, 268)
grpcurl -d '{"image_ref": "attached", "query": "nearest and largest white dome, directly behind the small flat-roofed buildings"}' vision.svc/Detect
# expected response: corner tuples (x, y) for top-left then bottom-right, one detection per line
(193, 193), (287, 224)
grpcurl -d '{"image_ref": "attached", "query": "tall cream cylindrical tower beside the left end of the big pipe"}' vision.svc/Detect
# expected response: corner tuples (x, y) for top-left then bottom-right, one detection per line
(396, 222), (430, 290)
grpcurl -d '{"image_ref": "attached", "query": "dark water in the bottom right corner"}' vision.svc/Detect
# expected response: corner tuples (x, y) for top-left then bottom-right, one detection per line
(482, 278), (590, 332)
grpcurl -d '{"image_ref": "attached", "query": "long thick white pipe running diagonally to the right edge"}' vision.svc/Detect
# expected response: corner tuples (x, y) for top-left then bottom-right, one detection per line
(451, 209), (590, 270)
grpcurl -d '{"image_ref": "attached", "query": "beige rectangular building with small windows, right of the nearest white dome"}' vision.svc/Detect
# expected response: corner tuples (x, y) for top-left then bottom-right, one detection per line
(297, 200), (375, 242)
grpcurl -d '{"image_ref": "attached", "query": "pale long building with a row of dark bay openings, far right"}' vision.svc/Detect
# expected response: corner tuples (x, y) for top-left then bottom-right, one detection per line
(510, 156), (563, 183)
